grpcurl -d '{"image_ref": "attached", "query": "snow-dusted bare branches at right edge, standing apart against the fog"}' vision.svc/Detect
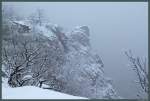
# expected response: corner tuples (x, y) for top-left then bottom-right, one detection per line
(125, 50), (148, 96)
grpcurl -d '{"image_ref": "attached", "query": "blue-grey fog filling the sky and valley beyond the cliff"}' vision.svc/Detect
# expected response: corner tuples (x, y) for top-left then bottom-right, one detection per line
(3, 2), (148, 98)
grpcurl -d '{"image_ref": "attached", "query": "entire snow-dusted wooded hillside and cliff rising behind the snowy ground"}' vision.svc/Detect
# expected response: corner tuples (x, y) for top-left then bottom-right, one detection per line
(2, 7), (119, 99)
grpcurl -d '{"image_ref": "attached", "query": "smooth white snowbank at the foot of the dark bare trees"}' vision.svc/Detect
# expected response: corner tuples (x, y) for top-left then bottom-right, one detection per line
(2, 78), (87, 99)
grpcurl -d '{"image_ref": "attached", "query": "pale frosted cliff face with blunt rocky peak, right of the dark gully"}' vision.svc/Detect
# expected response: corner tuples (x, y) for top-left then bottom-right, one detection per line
(44, 23), (118, 98)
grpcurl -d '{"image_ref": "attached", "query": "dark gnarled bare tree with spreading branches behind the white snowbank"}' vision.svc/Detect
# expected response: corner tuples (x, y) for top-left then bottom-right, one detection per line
(3, 35), (46, 87)
